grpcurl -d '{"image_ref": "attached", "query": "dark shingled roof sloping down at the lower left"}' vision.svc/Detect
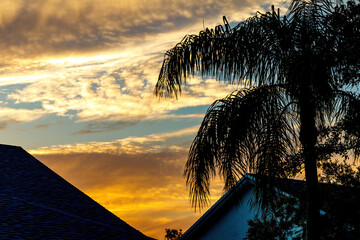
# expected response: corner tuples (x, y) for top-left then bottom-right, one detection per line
(0, 145), (152, 240)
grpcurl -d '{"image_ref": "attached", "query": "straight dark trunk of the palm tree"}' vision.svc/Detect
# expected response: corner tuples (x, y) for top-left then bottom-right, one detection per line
(300, 99), (320, 240)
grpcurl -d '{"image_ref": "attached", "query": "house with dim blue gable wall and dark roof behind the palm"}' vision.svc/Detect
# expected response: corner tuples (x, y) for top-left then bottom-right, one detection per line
(180, 174), (360, 240)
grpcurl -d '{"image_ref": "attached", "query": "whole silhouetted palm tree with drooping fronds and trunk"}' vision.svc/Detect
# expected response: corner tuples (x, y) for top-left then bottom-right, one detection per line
(155, 0), (360, 239)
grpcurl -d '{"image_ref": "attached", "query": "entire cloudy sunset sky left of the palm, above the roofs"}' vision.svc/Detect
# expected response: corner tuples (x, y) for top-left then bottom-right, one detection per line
(0, 0), (284, 239)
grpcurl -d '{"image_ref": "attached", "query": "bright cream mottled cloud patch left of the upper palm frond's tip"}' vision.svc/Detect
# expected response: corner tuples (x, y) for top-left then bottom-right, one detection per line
(7, 47), (239, 125)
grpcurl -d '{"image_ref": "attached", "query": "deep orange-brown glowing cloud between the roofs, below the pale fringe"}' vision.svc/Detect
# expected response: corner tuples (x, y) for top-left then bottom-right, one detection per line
(35, 150), (207, 239)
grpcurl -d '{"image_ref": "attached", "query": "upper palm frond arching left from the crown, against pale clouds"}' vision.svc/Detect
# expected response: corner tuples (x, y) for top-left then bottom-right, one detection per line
(155, 9), (291, 97)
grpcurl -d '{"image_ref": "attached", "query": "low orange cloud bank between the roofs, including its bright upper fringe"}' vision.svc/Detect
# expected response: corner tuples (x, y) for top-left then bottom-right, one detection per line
(30, 127), (222, 239)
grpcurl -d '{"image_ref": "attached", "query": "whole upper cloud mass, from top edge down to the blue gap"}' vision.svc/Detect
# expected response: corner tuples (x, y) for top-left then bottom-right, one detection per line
(0, 0), (286, 129)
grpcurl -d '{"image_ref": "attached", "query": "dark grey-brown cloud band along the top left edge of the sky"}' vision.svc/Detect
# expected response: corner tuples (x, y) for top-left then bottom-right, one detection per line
(0, 0), (253, 57)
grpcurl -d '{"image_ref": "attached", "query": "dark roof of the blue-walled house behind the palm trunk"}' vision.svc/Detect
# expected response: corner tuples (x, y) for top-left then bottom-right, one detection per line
(180, 174), (360, 240)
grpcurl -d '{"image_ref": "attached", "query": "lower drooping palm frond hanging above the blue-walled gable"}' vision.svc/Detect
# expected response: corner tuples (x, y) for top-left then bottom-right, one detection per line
(184, 85), (298, 207)
